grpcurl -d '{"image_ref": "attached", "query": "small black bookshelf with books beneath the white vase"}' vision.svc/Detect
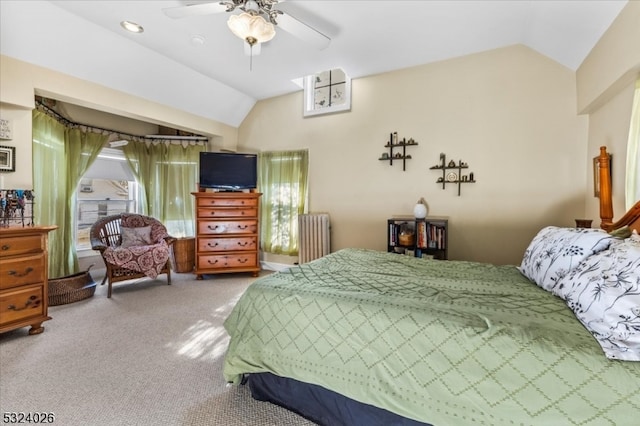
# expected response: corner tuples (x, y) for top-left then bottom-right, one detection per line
(387, 217), (449, 260)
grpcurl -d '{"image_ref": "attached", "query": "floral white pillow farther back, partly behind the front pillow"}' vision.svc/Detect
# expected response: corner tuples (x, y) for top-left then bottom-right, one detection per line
(518, 226), (615, 295)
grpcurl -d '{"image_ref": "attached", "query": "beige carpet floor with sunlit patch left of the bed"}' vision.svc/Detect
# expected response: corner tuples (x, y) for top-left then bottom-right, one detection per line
(0, 271), (313, 426)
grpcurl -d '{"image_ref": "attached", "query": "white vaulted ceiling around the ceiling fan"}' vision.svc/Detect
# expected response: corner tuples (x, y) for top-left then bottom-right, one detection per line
(0, 0), (627, 126)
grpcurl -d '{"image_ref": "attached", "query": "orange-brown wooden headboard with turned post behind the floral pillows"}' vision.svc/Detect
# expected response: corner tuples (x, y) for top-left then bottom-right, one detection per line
(598, 146), (640, 234)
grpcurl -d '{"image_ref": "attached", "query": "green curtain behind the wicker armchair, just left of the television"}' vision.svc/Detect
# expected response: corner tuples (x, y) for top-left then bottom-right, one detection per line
(123, 142), (205, 237)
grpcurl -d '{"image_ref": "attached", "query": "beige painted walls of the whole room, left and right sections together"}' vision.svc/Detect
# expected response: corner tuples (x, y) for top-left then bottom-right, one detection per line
(0, 2), (640, 263)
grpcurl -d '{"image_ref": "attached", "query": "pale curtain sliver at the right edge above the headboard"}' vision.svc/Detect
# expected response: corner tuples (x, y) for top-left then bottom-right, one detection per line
(625, 76), (640, 211)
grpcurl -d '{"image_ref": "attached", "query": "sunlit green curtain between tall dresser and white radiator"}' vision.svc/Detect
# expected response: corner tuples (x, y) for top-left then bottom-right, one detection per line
(258, 150), (309, 256)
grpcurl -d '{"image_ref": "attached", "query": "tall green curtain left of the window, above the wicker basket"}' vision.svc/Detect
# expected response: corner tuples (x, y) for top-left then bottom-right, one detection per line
(32, 110), (107, 278)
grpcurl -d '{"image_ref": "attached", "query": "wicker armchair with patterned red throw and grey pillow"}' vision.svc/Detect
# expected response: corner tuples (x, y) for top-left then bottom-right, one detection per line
(90, 213), (176, 297)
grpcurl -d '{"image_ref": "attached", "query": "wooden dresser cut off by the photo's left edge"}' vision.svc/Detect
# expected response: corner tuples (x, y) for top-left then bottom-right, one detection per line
(0, 226), (57, 334)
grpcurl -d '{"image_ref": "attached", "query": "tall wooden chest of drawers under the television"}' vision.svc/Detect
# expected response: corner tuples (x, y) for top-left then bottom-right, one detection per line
(191, 192), (262, 280)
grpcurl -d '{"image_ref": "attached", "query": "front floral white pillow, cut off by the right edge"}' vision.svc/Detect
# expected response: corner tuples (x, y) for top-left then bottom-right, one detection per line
(557, 238), (640, 361)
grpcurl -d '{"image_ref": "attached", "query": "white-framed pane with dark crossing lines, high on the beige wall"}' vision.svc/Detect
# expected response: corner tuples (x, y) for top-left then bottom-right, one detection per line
(304, 68), (351, 117)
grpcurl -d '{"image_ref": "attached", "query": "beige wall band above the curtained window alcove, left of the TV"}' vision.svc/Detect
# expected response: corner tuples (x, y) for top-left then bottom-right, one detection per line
(0, 55), (237, 188)
